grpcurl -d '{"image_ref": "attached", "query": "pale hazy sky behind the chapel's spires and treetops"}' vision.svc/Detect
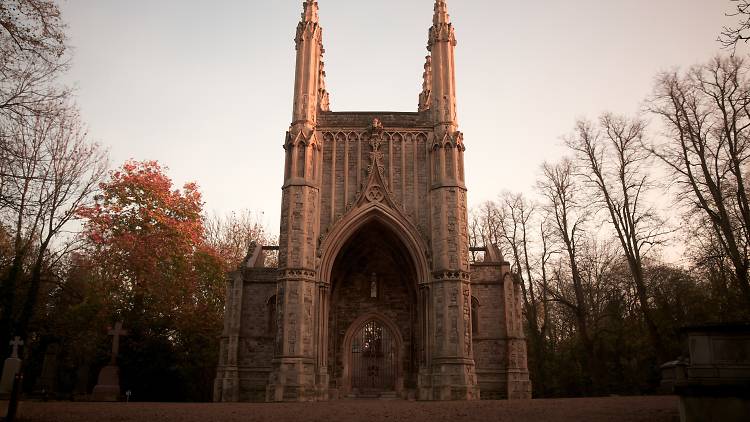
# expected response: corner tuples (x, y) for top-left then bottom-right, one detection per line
(62, 0), (731, 232)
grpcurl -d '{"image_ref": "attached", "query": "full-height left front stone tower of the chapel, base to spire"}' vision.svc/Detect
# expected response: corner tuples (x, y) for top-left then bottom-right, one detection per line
(266, 0), (328, 401)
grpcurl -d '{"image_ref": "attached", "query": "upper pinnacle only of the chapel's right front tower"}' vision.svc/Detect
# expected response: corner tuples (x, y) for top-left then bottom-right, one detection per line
(427, 0), (457, 132)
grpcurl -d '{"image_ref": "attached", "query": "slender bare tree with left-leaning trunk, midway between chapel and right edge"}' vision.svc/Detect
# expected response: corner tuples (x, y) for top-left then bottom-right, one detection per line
(566, 113), (670, 360)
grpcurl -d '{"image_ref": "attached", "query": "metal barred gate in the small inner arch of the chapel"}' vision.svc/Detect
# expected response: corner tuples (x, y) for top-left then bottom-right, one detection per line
(351, 320), (398, 394)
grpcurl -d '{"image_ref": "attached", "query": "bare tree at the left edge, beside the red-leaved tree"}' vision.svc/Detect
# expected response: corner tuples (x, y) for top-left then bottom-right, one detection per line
(0, 106), (107, 352)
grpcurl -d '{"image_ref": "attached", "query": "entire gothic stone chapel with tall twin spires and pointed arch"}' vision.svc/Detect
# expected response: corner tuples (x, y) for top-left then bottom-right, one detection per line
(214, 0), (531, 402)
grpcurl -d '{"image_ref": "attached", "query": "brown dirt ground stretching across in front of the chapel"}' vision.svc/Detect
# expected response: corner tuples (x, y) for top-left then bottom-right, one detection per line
(0, 396), (679, 422)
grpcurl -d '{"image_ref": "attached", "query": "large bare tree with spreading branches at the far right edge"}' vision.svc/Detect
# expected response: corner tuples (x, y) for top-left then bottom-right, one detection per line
(649, 57), (750, 305)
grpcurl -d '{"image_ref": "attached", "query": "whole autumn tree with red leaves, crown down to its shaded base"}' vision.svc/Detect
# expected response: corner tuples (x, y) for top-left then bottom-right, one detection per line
(79, 161), (225, 400)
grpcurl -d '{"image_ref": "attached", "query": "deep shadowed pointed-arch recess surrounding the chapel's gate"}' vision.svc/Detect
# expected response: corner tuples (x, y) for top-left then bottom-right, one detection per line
(328, 220), (420, 397)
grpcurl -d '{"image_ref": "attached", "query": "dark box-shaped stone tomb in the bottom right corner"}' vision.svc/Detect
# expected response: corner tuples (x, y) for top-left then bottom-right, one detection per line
(662, 323), (750, 422)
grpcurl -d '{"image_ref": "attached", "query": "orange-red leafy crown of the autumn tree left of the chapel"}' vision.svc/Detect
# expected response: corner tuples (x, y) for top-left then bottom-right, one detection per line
(79, 161), (223, 324)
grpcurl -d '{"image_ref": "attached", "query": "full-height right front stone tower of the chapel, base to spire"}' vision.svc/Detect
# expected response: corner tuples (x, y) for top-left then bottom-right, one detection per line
(420, 0), (479, 400)
